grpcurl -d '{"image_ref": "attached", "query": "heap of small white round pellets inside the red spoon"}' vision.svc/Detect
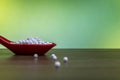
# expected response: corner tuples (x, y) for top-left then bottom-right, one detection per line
(14, 37), (52, 44)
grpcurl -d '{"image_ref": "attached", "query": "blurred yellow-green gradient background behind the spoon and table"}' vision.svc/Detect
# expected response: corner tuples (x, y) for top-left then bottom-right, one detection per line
(0, 0), (120, 48)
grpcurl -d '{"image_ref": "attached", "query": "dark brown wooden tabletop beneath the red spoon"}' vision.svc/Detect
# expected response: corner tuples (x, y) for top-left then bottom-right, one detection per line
(0, 49), (120, 80)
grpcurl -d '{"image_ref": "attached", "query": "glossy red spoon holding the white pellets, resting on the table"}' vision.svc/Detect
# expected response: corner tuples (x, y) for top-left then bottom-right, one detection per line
(0, 36), (56, 55)
